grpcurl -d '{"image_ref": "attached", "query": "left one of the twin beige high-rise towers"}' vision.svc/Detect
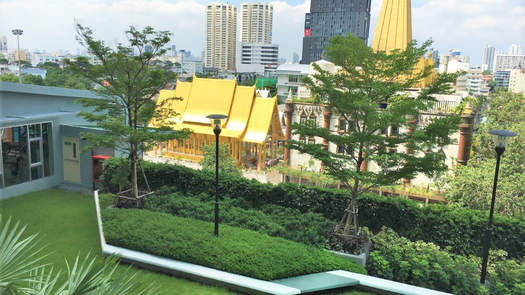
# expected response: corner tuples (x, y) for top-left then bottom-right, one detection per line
(204, 2), (237, 70)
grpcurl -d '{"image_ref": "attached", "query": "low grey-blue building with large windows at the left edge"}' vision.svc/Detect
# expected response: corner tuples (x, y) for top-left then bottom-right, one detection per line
(0, 82), (116, 199)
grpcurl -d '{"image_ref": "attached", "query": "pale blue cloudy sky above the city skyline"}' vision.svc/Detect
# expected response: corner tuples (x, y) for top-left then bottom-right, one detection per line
(0, 0), (525, 66)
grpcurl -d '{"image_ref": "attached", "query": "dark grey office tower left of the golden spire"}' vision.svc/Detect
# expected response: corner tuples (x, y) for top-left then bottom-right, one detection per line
(301, 0), (371, 64)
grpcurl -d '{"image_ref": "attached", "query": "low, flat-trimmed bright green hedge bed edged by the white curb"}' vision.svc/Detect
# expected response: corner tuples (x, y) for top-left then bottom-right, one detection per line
(102, 209), (366, 280)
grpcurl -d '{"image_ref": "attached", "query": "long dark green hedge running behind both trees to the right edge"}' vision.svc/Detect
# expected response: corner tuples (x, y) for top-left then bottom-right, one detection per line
(102, 159), (525, 258)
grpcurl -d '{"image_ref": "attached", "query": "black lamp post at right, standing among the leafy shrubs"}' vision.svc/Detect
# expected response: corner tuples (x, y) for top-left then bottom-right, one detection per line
(479, 130), (517, 284)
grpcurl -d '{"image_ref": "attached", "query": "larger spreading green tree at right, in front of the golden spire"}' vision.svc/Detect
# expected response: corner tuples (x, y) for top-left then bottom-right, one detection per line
(287, 35), (463, 235)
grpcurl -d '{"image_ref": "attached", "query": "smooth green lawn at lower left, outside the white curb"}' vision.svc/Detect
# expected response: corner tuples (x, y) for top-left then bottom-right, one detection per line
(0, 189), (372, 295)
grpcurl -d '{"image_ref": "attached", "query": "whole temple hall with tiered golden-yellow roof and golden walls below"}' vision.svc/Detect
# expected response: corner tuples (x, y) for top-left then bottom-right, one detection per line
(150, 77), (284, 170)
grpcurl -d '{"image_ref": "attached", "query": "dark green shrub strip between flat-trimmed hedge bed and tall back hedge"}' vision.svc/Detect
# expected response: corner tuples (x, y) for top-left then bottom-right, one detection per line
(144, 190), (335, 247)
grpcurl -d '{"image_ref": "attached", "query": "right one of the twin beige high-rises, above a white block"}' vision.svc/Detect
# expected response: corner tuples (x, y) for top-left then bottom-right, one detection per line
(240, 2), (273, 44)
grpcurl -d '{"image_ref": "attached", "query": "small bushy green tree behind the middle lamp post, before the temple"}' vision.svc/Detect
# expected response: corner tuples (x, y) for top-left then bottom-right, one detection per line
(200, 143), (242, 176)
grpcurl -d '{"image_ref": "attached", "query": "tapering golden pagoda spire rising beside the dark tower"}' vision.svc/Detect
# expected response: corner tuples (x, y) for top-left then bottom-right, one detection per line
(372, 0), (412, 53)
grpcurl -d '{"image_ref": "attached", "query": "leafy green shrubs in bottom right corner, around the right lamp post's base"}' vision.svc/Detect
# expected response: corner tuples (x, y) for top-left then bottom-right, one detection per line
(367, 228), (525, 295)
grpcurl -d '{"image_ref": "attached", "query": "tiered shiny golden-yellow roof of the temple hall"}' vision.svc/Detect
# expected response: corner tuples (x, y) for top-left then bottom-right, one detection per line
(150, 77), (284, 143)
